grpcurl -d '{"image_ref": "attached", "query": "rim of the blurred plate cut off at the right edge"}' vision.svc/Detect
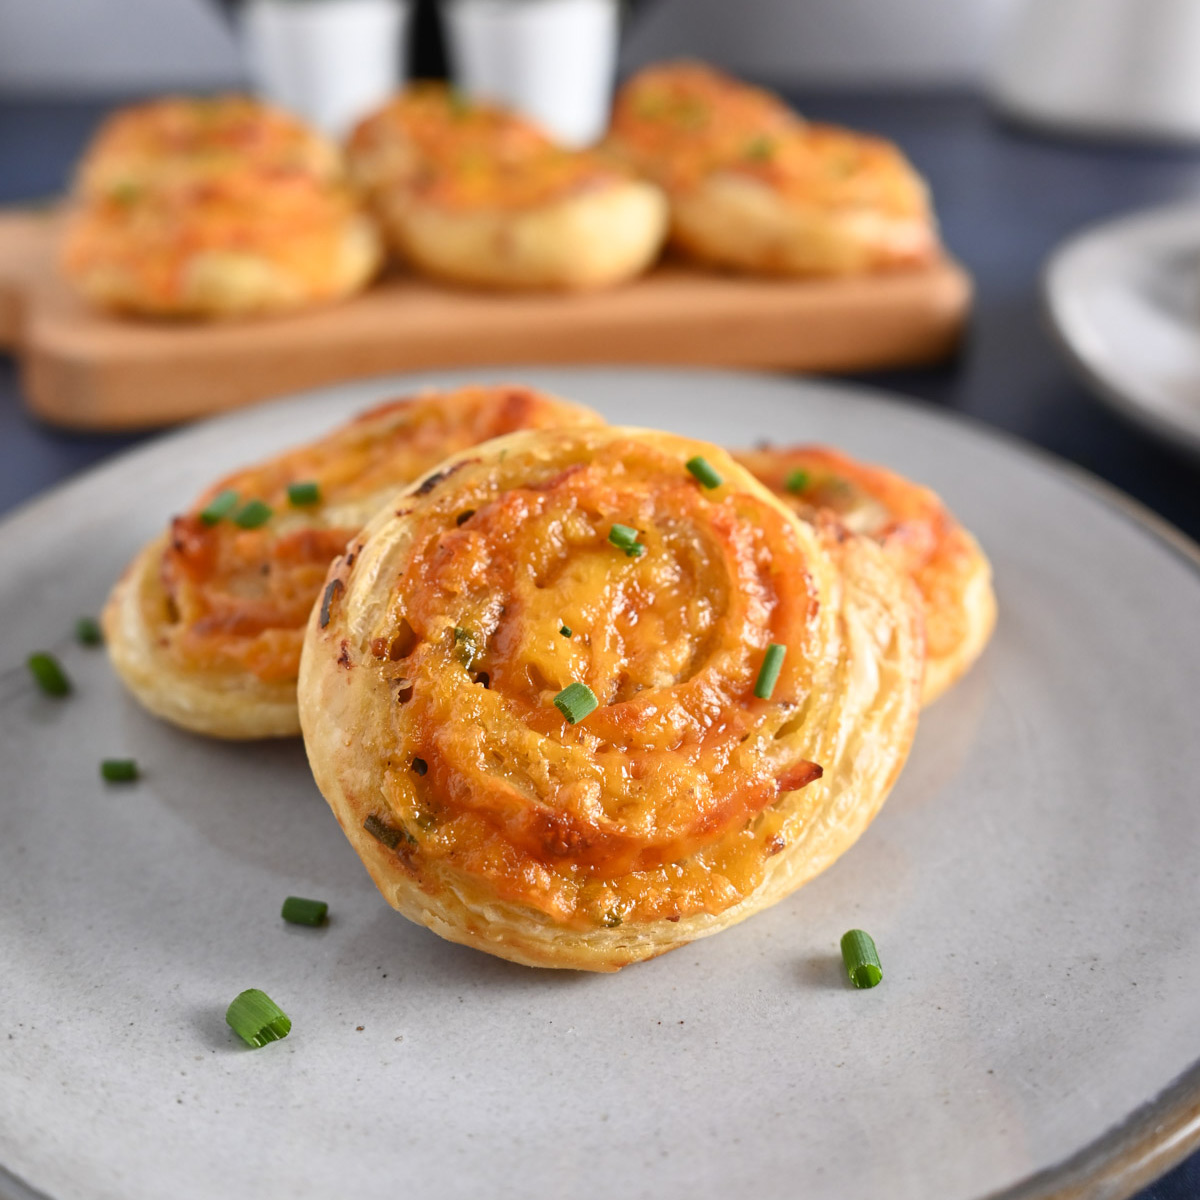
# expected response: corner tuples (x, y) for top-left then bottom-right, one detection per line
(1038, 200), (1200, 456)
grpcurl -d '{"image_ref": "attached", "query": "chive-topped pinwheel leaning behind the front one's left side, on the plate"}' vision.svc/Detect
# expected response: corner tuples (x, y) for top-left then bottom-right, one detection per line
(103, 386), (602, 739)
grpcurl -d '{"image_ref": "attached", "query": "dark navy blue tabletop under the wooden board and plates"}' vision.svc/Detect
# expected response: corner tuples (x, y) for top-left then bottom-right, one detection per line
(0, 90), (1200, 1200)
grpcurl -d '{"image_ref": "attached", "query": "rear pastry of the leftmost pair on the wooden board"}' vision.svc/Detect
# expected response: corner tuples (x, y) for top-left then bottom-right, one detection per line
(73, 95), (343, 199)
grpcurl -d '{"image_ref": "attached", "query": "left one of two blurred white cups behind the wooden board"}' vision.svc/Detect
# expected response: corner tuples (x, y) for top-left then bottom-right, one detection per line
(242, 0), (412, 137)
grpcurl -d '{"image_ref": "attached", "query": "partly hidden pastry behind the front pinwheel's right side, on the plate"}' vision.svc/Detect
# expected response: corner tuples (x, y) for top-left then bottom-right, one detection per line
(733, 446), (996, 704)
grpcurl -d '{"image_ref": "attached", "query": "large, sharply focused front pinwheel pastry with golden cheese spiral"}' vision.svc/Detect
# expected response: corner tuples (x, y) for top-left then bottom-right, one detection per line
(299, 427), (922, 971)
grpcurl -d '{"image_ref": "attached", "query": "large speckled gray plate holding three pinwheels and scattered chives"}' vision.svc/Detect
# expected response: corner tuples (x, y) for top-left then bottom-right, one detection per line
(0, 370), (1200, 1200)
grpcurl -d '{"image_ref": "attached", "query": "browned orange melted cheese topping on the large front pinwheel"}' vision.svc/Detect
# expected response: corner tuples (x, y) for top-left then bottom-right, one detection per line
(326, 431), (834, 929)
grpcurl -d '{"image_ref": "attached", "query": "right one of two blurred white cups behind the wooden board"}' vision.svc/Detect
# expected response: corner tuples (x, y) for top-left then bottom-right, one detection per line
(443, 0), (619, 146)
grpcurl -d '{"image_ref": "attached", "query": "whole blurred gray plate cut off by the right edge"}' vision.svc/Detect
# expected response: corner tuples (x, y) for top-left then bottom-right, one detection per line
(1043, 200), (1200, 455)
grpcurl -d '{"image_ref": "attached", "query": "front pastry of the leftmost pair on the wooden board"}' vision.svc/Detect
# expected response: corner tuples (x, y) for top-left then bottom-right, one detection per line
(61, 173), (383, 318)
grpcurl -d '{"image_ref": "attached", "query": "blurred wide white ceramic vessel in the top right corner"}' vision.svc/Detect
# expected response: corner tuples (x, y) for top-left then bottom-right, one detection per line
(991, 0), (1200, 139)
